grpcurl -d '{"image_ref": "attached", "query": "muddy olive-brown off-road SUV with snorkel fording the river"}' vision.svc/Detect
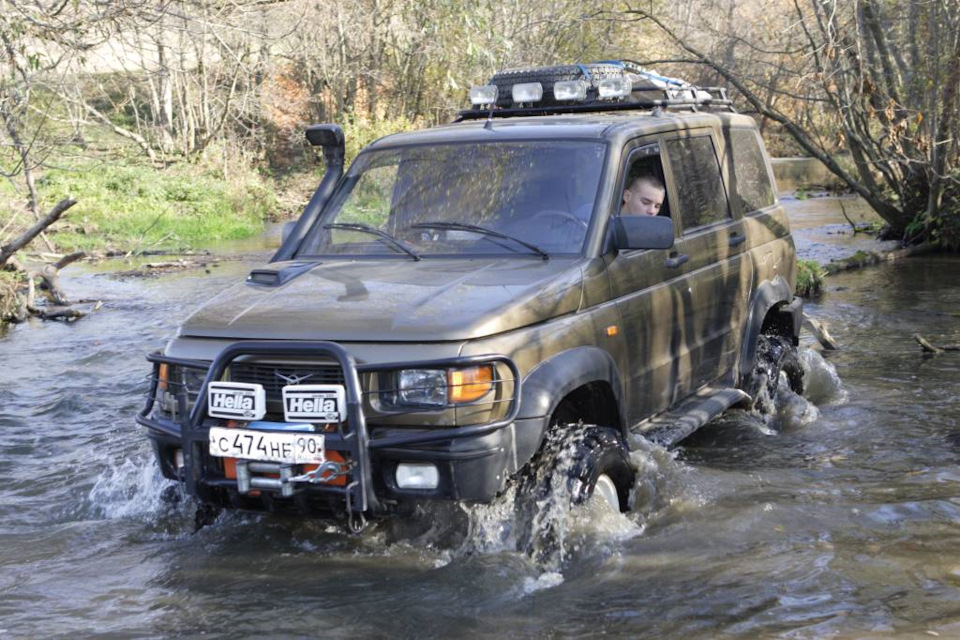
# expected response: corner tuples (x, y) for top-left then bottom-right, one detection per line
(138, 62), (802, 528)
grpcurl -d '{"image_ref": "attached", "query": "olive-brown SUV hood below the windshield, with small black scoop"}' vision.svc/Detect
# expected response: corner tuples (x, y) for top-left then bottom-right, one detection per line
(180, 258), (583, 342)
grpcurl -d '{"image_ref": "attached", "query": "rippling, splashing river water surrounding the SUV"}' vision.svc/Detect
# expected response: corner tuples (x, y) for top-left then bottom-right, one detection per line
(0, 205), (960, 639)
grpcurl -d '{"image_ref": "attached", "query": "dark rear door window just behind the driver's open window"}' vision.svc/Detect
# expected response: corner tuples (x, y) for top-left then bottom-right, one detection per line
(666, 136), (730, 232)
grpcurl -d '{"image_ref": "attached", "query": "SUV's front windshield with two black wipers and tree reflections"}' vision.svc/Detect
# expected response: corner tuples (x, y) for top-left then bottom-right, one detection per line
(297, 140), (605, 259)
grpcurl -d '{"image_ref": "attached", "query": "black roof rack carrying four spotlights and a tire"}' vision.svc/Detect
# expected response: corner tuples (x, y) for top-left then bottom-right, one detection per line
(455, 60), (736, 122)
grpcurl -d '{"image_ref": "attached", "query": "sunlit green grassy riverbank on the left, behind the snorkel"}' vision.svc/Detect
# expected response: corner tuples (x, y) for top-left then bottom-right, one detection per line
(0, 117), (415, 253)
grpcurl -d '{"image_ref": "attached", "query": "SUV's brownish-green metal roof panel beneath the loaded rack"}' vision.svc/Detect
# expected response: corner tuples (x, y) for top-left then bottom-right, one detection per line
(369, 111), (756, 149)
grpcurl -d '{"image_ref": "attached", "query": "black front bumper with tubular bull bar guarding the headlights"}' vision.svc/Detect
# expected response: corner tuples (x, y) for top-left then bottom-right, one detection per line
(137, 341), (516, 514)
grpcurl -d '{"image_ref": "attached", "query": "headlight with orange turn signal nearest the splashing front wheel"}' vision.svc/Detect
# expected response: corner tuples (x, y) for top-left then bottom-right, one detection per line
(381, 364), (494, 407)
